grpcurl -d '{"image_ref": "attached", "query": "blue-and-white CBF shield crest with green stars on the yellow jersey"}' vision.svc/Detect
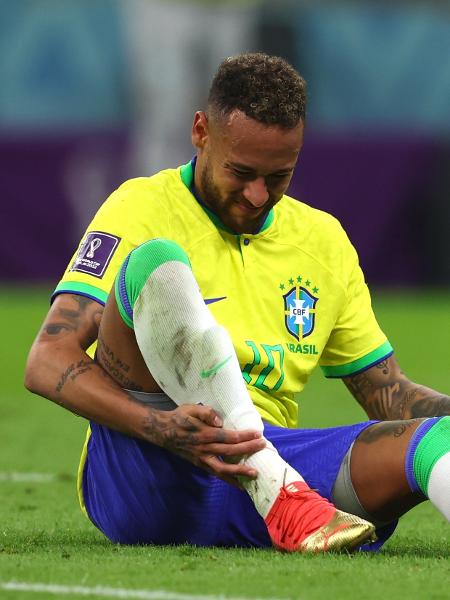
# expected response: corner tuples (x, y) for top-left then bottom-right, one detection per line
(280, 276), (319, 340)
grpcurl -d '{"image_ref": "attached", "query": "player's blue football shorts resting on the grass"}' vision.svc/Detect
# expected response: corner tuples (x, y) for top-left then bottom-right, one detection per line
(82, 421), (394, 550)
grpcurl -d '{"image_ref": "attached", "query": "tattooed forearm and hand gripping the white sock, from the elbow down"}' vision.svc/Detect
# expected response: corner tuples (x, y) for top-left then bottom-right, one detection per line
(25, 344), (265, 485)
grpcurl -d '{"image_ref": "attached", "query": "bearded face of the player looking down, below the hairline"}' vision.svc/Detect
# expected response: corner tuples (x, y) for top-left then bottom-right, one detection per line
(192, 110), (303, 233)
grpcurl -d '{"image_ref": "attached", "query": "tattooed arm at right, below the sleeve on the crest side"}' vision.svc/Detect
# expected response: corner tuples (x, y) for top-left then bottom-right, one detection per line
(344, 356), (450, 421)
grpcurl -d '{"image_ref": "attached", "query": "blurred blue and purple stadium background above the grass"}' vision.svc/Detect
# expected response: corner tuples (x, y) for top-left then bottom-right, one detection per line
(0, 0), (450, 286)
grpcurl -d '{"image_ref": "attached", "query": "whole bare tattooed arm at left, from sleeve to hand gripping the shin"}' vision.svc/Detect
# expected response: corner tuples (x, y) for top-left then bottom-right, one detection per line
(25, 294), (264, 483)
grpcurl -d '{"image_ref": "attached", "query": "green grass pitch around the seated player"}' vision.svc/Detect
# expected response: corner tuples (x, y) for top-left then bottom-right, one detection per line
(0, 287), (450, 600)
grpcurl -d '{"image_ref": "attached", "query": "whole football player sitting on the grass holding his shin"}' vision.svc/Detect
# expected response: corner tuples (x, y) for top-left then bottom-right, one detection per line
(26, 54), (450, 552)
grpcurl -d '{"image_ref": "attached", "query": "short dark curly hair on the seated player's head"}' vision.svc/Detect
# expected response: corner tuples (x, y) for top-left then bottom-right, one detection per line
(208, 52), (306, 129)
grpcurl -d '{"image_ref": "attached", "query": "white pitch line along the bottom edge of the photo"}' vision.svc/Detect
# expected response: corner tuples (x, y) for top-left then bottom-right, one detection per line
(0, 581), (280, 600)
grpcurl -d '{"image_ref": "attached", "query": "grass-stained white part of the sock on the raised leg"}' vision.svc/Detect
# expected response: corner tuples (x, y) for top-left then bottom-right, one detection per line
(133, 261), (303, 517)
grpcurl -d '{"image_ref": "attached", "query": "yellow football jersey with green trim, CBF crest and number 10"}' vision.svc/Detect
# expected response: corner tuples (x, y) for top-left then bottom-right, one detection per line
(55, 163), (392, 427)
